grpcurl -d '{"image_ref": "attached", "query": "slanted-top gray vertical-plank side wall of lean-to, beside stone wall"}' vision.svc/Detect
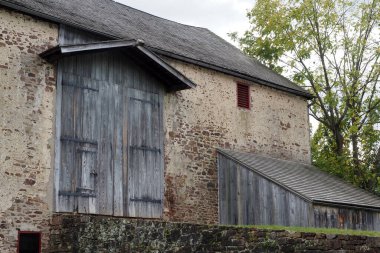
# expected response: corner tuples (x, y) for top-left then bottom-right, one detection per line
(218, 154), (313, 226)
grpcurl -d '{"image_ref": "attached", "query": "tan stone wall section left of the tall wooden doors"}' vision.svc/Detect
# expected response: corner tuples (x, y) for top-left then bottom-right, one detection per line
(0, 7), (58, 253)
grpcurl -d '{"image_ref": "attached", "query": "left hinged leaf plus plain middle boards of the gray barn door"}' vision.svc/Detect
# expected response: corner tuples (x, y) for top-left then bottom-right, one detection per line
(56, 73), (127, 216)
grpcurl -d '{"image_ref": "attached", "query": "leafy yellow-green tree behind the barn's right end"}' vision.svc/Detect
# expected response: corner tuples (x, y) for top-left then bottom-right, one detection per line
(230, 0), (380, 191)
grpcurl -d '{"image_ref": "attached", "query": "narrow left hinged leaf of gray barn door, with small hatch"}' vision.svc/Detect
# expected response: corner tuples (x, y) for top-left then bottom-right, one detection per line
(57, 74), (99, 213)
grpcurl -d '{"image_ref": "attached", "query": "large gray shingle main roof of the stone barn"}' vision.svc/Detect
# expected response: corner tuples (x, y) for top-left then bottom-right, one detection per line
(0, 0), (311, 98)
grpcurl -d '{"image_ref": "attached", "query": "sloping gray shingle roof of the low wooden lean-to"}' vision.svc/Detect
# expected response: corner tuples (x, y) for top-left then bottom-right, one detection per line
(219, 150), (380, 209)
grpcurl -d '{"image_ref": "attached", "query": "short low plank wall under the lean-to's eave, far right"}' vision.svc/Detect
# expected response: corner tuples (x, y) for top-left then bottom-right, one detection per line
(313, 205), (380, 231)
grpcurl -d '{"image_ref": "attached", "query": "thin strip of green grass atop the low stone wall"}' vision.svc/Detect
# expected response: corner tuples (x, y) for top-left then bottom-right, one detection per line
(239, 225), (380, 237)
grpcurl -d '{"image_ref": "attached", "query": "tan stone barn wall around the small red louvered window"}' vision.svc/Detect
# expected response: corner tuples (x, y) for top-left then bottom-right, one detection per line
(164, 59), (311, 223)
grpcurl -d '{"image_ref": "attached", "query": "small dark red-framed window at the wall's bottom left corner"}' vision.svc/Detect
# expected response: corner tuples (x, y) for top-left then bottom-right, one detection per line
(18, 231), (41, 253)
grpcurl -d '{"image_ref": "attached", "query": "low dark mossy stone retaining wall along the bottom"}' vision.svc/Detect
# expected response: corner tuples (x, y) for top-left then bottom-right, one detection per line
(49, 215), (380, 253)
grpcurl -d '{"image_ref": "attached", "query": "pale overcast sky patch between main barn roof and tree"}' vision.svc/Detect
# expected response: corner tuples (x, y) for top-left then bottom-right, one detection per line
(116, 0), (254, 42)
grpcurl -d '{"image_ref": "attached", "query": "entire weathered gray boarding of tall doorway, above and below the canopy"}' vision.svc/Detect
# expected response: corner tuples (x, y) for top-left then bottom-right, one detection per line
(55, 27), (164, 218)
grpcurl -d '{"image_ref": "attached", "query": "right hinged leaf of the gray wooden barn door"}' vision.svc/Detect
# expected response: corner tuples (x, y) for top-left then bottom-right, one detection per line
(128, 89), (164, 218)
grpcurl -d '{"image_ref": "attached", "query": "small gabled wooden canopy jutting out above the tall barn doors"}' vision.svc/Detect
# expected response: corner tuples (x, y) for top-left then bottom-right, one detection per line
(40, 40), (196, 91)
